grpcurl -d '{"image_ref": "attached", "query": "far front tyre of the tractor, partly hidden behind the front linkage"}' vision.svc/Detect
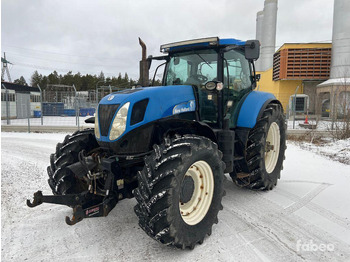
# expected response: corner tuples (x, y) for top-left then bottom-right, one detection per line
(47, 129), (98, 195)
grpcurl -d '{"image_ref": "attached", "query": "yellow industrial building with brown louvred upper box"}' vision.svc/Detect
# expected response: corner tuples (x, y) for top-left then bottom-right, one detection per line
(258, 43), (332, 113)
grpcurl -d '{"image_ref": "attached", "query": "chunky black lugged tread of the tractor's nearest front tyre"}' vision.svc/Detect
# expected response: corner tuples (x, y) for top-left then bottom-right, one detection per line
(134, 135), (224, 249)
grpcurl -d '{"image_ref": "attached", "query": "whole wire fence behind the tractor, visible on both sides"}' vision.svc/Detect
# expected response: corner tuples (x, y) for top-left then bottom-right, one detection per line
(1, 85), (350, 132)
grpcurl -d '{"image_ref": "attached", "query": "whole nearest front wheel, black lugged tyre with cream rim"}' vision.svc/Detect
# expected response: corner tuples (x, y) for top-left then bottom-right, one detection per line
(134, 135), (225, 249)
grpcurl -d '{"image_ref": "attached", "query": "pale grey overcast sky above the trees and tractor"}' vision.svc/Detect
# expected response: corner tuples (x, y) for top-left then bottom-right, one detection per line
(1, 0), (334, 83)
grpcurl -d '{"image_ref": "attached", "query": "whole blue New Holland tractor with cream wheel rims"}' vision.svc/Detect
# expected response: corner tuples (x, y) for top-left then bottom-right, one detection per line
(27, 37), (286, 249)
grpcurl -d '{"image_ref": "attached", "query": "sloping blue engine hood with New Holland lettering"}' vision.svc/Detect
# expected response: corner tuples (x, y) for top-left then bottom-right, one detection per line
(98, 85), (196, 142)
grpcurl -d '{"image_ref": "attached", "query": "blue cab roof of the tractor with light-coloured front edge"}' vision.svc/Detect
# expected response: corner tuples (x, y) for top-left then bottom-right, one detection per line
(160, 37), (245, 53)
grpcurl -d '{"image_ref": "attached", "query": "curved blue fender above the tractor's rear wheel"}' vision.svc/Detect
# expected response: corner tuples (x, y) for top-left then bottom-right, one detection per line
(237, 91), (276, 128)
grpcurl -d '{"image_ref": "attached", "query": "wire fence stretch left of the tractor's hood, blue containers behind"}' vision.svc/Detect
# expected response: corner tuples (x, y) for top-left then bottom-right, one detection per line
(1, 85), (120, 132)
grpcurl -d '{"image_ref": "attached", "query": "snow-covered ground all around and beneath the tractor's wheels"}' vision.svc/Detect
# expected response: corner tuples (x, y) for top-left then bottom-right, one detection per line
(1, 133), (350, 261)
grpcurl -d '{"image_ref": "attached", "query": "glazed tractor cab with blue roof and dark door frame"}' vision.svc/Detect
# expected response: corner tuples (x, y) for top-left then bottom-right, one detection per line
(149, 37), (259, 128)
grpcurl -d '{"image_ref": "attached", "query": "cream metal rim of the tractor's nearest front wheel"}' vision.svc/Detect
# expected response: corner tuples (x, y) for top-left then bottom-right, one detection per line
(179, 160), (214, 225)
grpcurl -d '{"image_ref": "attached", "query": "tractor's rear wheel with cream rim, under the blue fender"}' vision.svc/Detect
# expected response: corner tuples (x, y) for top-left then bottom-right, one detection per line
(231, 104), (286, 190)
